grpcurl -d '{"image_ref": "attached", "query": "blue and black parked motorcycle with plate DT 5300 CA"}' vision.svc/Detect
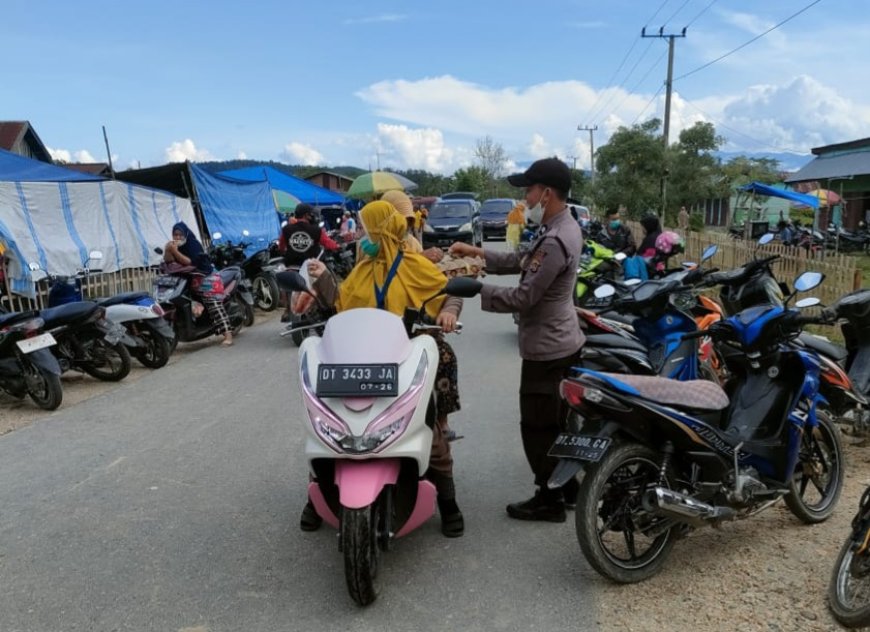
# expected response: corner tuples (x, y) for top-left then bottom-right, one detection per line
(549, 272), (843, 583)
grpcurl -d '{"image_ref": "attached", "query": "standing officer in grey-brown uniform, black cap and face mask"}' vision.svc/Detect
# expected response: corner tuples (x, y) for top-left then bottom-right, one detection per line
(450, 158), (585, 522)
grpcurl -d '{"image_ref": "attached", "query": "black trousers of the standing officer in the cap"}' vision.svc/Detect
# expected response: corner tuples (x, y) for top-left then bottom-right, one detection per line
(520, 352), (579, 490)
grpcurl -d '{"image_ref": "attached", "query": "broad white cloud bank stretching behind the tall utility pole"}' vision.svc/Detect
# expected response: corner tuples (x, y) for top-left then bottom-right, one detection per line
(357, 75), (870, 165)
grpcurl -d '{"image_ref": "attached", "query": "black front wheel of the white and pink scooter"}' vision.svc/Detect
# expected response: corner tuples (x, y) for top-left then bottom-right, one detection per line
(341, 503), (379, 606)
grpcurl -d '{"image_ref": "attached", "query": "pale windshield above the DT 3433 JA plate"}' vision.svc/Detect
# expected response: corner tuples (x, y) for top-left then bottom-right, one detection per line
(320, 307), (411, 364)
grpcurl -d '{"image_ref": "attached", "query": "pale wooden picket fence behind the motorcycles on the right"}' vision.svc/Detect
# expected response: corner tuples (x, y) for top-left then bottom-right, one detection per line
(628, 222), (861, 305)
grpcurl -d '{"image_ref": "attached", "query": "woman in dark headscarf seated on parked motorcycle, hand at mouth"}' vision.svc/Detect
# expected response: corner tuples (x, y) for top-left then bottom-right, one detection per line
(163, 222), (233, 347)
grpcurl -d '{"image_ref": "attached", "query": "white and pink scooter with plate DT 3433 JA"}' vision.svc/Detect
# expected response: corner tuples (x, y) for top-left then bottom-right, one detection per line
(279, 272), (480, 606)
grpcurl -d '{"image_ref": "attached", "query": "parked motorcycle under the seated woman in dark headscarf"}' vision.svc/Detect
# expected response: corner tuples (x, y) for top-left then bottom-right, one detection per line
(153, 248), (254, 343)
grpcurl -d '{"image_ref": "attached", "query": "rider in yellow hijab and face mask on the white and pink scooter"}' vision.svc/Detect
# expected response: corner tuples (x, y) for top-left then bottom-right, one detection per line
(300, 200), (465, 538)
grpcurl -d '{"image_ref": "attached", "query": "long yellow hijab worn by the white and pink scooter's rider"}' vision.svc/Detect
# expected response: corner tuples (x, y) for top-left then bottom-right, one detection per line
(336, 200), (447, 318)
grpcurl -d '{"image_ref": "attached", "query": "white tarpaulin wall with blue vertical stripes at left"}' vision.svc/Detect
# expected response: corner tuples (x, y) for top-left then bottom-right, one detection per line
(0, 180), (199, 298)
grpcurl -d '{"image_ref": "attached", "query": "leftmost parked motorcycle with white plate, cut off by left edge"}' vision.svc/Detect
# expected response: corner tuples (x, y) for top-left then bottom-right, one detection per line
(0, 308), (63, 410)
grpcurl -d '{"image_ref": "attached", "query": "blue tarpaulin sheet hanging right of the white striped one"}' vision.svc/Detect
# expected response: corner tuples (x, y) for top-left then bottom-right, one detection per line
(190, 164), (281, 254)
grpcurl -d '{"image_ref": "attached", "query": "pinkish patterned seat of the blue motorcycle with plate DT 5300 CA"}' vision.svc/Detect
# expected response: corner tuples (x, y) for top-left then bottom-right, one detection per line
(581, 369), (729, 410)
